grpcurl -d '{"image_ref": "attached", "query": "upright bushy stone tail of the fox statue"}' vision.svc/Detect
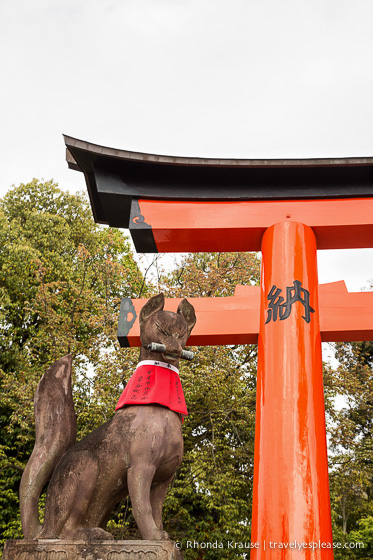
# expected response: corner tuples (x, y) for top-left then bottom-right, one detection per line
(19, 354), (76, 539)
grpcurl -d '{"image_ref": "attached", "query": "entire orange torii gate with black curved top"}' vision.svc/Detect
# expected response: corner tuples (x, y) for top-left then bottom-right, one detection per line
(65, 137), (373, 560)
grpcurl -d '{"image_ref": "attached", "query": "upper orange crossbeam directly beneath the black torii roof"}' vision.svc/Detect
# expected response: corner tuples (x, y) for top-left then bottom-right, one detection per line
(139, 198), (373, 253)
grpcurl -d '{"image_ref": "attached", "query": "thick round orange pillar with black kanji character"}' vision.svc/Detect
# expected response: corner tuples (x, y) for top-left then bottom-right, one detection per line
(250, 222), (333, 560)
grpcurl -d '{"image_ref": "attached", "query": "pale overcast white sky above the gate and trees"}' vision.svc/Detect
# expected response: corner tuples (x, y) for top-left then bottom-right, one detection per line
(0, 0), (373, 290)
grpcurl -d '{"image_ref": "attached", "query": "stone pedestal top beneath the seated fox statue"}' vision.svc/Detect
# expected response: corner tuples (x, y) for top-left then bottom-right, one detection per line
(3, 539), (184, 560)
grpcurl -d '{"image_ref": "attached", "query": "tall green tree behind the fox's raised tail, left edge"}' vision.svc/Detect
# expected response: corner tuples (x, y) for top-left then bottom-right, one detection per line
(0, 180), (142, 540)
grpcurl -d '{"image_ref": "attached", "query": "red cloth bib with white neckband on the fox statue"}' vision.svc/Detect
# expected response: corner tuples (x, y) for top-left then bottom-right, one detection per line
(115, 360), (188, 416)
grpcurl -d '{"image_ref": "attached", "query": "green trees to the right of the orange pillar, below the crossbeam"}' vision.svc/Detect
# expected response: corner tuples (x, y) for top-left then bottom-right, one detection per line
(329, 316), (373, 558)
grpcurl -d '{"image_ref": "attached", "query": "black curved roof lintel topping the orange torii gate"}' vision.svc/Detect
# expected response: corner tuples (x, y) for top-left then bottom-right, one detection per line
(64, 135), (373, 228)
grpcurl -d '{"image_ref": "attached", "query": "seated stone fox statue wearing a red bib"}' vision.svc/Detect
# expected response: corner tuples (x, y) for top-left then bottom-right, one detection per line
(20, 294), (196, 540)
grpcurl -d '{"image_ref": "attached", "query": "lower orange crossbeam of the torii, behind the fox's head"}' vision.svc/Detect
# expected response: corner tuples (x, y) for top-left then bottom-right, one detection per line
(122, 281), (373, 346)
